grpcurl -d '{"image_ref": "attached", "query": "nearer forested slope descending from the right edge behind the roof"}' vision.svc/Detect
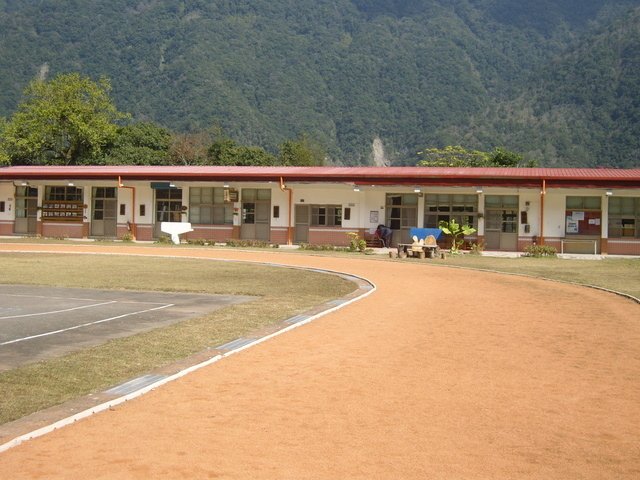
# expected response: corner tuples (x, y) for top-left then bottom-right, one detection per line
(456, 8), (640, 167)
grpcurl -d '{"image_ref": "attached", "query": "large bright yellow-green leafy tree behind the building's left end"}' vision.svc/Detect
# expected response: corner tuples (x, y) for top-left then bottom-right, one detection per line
(1, 73), (127, 165)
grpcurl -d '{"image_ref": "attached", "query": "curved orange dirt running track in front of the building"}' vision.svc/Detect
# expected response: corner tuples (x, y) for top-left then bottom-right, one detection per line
(0, 245), (640, 480)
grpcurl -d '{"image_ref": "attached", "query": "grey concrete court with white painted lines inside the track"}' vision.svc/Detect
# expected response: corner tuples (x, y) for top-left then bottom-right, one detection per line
(0, 285), (252, 371)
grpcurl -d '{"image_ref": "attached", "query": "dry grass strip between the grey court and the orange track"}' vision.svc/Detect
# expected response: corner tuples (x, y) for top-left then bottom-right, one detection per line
(0, 253), (355, 424)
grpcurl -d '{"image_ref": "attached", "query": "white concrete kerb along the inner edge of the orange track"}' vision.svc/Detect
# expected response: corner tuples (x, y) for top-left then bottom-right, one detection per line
(0, 250), (377, 453)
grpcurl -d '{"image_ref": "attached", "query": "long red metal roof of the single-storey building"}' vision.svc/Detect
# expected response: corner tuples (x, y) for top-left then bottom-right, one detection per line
(0, 165), (640, 188)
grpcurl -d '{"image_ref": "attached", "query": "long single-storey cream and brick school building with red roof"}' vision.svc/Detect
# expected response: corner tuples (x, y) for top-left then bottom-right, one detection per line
(0, 166), (640, 255)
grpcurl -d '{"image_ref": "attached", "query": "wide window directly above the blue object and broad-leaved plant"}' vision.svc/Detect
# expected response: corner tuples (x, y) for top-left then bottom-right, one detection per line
(424, 194), (478, 228)
